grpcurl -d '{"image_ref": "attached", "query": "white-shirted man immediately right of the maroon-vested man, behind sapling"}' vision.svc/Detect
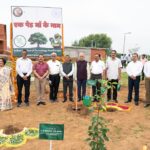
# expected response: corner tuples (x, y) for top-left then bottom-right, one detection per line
(90, 54), (105, 102)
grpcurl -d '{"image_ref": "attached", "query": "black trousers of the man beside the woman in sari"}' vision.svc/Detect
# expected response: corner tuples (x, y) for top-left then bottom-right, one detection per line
(17, 75), (30, 103)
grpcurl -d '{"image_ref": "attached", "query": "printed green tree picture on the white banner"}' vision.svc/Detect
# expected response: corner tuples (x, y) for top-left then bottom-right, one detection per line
(28, 32), (47, 47)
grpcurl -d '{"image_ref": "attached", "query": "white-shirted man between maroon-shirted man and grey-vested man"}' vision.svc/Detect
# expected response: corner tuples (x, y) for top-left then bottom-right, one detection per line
(47, 53), (61, 102)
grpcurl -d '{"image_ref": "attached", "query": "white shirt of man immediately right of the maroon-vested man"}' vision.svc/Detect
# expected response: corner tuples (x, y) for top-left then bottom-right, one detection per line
(90, 60), (105, 74)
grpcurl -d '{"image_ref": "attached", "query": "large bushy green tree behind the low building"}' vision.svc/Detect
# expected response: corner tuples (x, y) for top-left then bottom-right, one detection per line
(72, 34), (112, 48)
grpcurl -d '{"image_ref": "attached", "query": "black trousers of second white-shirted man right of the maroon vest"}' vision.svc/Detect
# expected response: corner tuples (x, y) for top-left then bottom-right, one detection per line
(107, 79), (118, 100)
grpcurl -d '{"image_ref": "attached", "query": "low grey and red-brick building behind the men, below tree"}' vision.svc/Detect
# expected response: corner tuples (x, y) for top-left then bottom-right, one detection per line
(64, 46), (106, 62)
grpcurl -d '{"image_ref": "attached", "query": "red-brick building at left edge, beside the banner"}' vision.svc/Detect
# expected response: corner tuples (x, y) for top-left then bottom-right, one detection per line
(0, 24), (7, 54)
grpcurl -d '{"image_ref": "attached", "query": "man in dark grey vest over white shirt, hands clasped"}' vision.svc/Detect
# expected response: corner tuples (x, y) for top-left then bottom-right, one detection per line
(61, 55), (74, 102)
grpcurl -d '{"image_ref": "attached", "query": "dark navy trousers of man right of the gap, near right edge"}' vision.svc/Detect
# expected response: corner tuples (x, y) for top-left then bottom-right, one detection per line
(128, 76), (140, 102)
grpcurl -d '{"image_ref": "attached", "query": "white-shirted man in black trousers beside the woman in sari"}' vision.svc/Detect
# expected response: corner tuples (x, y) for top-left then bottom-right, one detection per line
(16, 49), (32, 107)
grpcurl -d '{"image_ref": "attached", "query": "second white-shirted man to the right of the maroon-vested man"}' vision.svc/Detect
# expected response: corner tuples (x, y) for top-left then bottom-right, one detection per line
(106, 50), (122, 103)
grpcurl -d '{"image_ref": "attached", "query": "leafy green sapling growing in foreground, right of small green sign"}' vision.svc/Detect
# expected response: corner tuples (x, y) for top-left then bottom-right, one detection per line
(86, 80), (110, 150)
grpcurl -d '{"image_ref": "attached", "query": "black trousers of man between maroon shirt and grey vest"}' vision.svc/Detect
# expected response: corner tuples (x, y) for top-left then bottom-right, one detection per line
(49, 74), (60, 101)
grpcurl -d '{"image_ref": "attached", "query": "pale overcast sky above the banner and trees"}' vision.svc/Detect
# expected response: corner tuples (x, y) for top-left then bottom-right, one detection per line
(0, 0), (150, 54)
